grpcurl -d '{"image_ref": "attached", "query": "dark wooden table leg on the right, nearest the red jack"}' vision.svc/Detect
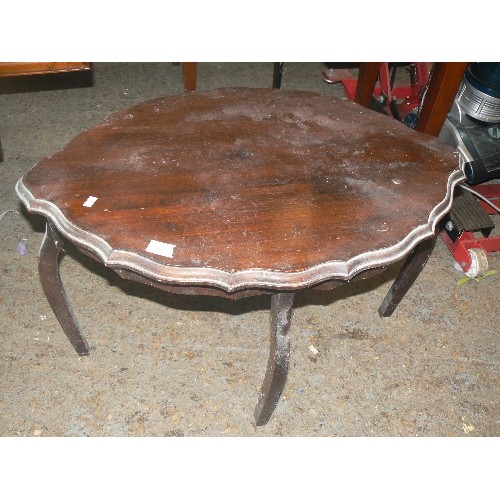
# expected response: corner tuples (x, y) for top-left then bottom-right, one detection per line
(378, 236), (436, 317)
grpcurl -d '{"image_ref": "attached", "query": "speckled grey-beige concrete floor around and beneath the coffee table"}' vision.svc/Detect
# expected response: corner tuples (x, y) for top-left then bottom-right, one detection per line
(0, 63), (500, 436)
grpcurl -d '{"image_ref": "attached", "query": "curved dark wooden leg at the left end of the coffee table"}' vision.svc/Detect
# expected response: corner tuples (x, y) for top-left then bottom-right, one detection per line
(38, 221), (90, 356)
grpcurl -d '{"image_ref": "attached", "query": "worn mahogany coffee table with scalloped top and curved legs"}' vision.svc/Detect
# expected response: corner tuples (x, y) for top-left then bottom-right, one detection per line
(16, 89), (464, 425)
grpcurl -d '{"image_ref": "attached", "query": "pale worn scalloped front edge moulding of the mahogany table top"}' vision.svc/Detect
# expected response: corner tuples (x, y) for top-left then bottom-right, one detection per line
(15, 169), (465, 293)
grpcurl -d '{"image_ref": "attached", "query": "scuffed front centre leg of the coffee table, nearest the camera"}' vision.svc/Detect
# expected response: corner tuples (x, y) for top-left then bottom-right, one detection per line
(255, 293), (294, 425)
